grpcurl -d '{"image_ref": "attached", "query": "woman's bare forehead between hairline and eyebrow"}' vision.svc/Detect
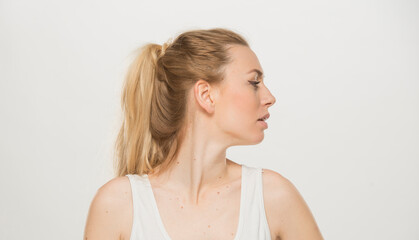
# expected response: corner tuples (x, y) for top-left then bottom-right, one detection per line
(225, 45), (262, 80)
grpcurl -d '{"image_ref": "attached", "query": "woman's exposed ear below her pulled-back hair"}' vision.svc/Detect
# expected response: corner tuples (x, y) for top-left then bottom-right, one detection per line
(194, 79), (218, 114)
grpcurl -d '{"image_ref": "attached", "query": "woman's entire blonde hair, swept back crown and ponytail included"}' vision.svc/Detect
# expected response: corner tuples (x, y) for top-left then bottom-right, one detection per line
(114, 28), (248, 176)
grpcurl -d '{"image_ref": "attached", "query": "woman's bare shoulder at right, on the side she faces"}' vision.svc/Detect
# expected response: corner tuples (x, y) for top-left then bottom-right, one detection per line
(262, 169), (323, 240)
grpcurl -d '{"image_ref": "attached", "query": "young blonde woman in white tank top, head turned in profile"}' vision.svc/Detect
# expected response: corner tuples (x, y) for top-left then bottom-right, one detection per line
(84, 29), (323, 240)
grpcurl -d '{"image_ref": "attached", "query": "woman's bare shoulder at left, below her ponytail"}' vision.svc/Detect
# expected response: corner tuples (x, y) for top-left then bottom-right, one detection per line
(84, 176), (132, 240)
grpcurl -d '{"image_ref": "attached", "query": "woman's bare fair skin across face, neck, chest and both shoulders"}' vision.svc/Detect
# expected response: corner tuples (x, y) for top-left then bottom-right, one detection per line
(84, 45), (323, 240)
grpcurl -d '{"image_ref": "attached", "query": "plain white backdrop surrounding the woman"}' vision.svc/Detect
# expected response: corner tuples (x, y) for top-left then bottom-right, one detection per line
(0, 0), (419, 240)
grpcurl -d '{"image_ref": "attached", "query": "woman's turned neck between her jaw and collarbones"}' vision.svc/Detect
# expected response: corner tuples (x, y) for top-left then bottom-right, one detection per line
(149, 116), (232, 205)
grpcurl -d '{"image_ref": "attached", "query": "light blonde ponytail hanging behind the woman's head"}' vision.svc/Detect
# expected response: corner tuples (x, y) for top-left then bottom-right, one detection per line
(114, 44), (167, 176)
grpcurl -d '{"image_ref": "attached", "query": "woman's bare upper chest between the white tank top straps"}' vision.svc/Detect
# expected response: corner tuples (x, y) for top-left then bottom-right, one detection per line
(154, 183), (241, 240)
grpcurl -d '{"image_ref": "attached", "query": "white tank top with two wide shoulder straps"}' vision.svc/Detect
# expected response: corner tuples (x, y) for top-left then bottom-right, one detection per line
(126, 164), (271, 240)
